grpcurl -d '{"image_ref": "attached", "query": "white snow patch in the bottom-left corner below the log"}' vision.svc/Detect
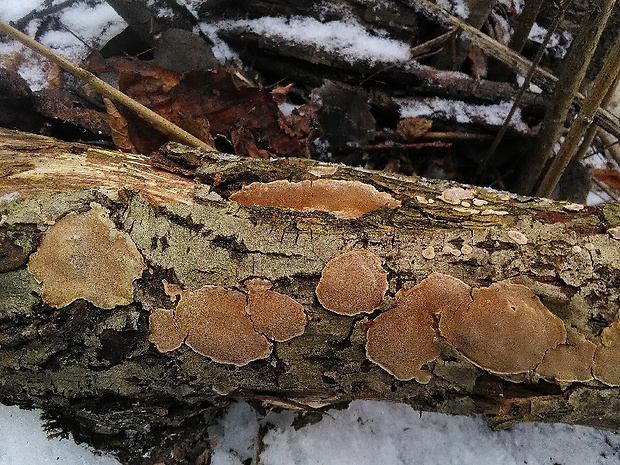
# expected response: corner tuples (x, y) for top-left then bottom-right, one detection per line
(0, 405), (119, 465)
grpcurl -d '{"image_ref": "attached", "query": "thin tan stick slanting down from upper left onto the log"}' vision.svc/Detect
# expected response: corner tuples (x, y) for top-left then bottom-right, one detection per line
(0, 21), (215, 150)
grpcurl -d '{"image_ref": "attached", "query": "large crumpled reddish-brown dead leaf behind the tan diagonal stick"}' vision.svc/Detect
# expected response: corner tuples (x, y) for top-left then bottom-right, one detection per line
(94, 59), (308, 157)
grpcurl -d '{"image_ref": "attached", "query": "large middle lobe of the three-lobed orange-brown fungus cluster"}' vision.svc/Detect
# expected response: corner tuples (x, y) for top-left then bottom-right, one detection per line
(175, 286), (272, 366)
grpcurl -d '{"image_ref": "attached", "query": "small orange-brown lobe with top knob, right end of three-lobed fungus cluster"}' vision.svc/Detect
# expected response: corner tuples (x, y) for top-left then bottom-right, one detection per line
(245, 279), (306, 342)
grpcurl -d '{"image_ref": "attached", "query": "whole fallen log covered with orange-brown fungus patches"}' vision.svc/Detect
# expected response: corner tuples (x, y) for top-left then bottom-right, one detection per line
(0, 130), (620, 464)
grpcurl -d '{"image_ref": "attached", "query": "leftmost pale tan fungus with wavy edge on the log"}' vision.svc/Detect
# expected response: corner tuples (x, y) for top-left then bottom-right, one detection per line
(28, 203), (145, 308)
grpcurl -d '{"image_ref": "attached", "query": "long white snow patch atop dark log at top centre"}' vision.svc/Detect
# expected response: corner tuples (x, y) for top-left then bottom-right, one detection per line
(218, 16), (411, 64)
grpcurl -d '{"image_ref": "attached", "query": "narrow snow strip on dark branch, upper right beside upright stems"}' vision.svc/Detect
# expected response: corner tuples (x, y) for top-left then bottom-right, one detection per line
(396, 97), (528, 132)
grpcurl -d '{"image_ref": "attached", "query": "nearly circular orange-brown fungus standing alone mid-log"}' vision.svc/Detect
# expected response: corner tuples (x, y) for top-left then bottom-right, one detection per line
(316, 249), (388, 315)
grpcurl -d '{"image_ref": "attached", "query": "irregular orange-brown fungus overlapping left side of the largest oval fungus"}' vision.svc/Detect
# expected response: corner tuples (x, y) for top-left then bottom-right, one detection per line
(366, 273), (471, 384)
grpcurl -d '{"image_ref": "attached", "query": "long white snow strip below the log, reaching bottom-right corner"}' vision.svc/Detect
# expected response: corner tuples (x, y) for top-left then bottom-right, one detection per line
(209, 401), (620, 465)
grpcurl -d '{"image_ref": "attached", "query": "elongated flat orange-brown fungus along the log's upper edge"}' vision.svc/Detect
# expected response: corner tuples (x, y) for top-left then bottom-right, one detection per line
(230, 179), (401, 219)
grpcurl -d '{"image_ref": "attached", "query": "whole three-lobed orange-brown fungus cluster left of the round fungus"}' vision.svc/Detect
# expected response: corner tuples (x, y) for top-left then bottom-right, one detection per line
(149, 279), (307, 366)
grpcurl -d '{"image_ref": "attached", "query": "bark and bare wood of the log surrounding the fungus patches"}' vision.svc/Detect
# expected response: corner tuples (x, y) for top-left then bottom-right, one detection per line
(0, 130), (620, 463)
